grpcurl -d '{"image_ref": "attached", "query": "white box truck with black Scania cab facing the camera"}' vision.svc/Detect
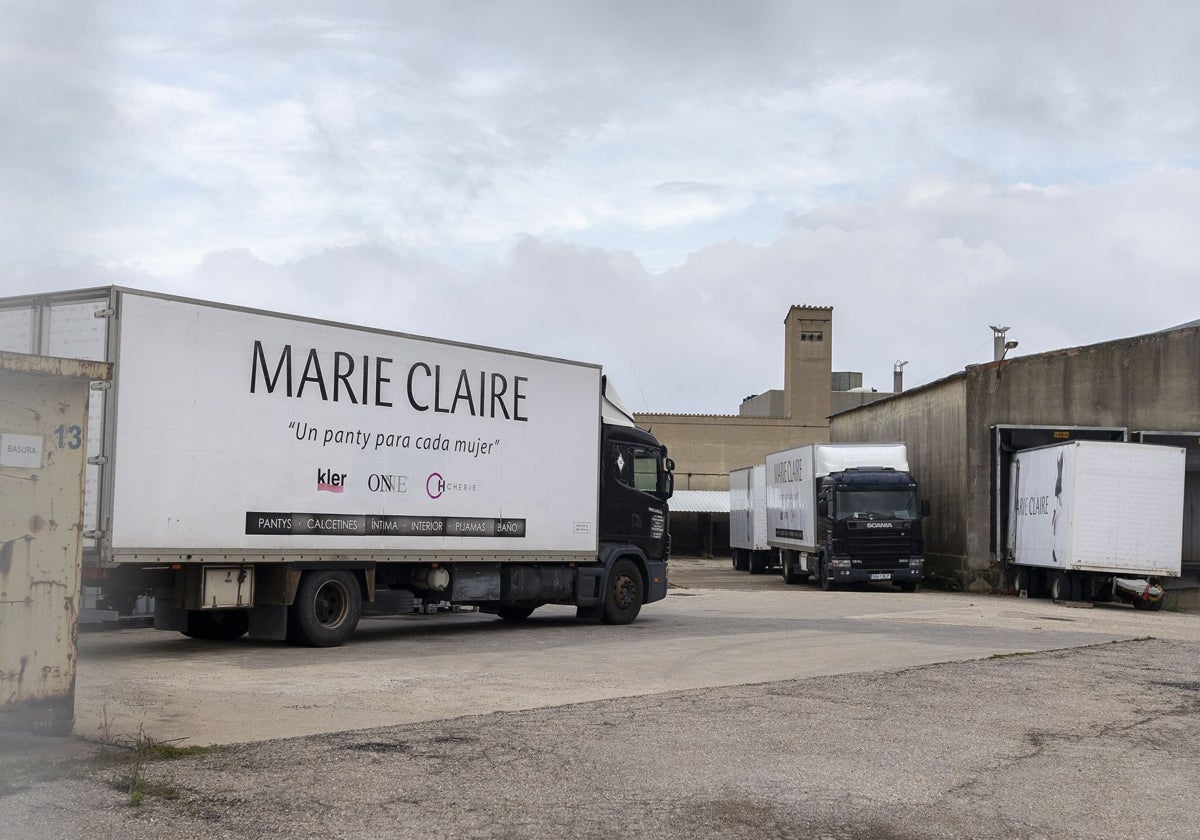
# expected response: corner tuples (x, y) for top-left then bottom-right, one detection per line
(766, 443), (929, 592)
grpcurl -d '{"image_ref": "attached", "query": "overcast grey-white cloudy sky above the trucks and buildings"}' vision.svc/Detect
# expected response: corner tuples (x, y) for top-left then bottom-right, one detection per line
(0, 0), (1200, 414)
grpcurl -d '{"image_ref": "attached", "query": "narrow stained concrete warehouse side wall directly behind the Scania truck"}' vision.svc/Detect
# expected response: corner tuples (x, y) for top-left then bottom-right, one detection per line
(829, 376), (967, 586)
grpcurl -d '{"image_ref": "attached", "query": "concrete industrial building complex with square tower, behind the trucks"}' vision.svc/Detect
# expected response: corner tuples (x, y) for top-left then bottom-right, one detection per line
(637, 306), (1200, 607)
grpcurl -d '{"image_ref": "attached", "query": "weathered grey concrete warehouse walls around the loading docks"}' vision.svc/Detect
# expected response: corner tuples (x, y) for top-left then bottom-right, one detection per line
(830, 328), (1200, 590)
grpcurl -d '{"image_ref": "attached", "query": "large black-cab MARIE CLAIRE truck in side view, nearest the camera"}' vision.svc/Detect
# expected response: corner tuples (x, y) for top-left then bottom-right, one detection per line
(0, 287), (673, 646)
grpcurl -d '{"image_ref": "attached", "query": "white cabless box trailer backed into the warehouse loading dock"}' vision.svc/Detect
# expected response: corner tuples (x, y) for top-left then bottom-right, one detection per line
(1006, 440), (1187, 610)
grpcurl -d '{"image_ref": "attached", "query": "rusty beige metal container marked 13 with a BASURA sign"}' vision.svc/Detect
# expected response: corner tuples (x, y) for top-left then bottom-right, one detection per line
(0, 353), (109, 733)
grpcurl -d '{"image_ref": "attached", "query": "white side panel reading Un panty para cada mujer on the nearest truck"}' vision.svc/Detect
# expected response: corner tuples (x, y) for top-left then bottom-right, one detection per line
(109, 292), (600, 559)
